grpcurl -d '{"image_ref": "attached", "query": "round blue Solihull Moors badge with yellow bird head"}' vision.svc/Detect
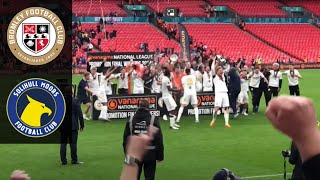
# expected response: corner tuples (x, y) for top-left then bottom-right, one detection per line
(7, 78), (66, 138)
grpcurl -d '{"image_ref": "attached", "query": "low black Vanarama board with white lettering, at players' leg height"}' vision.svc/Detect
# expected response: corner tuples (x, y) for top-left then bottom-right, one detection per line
(94, 92), (214, 119)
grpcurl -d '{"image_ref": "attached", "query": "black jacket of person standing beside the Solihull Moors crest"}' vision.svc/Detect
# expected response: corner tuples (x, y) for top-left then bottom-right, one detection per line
(59, 97), (84, 132)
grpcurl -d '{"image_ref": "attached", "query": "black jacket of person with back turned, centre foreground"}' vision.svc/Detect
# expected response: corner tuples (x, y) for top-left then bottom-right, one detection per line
(122, 108), (164, 161)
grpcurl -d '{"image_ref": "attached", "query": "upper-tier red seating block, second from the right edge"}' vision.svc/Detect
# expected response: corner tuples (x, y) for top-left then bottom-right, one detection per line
(208, 0), (286, 18)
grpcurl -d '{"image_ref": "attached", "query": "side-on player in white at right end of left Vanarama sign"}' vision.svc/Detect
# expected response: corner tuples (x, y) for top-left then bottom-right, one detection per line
(161, 69), (180, 130)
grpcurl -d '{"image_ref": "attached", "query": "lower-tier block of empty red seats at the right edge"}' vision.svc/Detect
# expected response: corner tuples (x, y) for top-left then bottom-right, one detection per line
(246, 24), (320, 60)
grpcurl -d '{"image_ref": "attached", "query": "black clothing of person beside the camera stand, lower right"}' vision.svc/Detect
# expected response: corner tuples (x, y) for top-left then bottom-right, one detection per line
(289, 143), (305, 180)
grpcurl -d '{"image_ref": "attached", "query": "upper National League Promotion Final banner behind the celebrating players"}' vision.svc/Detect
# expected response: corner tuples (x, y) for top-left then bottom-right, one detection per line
(87, 52), (154, 72)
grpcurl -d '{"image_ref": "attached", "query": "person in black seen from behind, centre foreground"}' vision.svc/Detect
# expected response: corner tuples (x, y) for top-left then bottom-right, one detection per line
(123, 100), (164, 180)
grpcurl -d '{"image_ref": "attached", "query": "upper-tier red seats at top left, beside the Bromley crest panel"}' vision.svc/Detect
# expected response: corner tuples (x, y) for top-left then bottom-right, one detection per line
(72, 0), (127, 17)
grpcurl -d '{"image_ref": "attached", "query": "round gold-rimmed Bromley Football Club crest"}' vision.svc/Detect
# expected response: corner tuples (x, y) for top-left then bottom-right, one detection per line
(7, 7), (65, 65)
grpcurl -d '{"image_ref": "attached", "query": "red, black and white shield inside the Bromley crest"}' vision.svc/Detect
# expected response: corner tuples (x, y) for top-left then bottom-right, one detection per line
(22, 24), (50, 54)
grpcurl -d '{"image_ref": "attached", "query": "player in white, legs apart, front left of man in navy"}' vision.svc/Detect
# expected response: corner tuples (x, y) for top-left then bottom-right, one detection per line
(210, 66), (231, 128)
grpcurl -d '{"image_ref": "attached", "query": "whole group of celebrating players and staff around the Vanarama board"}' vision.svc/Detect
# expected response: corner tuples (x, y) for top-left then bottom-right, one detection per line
(77, 56), (302, 130)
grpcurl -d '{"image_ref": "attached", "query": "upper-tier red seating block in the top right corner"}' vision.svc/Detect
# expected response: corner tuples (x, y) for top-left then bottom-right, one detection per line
(281, 0), (320, 16)
